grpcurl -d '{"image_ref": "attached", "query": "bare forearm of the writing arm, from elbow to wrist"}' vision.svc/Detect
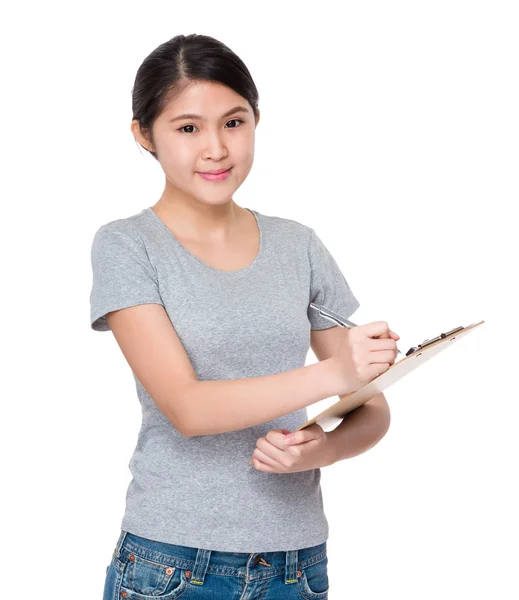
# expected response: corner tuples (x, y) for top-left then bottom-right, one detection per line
(182, 360), (340, 437)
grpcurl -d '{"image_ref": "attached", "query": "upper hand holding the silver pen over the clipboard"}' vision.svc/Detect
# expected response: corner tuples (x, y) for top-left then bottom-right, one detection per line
(331, 321), (400, 396)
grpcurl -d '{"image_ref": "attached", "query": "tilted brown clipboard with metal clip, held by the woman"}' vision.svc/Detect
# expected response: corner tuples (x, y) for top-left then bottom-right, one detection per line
(294, 321), (485, 431)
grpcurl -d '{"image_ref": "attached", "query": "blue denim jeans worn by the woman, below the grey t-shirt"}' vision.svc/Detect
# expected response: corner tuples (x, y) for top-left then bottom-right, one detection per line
(103, 530), (329, 600)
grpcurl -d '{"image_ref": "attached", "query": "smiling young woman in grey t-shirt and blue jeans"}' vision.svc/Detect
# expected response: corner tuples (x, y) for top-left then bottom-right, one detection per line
(90, 34), (398, 600)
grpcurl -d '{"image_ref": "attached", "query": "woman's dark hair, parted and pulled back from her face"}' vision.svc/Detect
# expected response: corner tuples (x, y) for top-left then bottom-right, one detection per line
(132, 33), (259, 160)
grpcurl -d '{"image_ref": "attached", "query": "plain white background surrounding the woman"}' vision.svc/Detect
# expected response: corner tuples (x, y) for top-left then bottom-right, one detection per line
(1, 0), (519, 600)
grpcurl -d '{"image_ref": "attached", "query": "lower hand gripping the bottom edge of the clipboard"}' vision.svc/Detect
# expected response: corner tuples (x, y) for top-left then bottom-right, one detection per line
(252, 423), (334, 473)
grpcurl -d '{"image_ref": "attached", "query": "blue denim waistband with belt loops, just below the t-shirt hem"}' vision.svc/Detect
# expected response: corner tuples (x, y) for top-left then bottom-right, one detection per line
(114, 530), (326, 583)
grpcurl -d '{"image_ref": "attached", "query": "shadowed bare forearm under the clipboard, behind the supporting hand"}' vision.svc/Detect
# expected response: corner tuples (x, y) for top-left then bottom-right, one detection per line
(326, 402), (391, 464)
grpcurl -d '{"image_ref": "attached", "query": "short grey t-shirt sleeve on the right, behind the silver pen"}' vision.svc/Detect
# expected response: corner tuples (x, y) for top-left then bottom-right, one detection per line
(308, 229), (360, 329)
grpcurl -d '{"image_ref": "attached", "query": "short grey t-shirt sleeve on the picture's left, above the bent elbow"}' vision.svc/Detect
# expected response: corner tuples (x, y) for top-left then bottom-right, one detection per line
(90, 224), (164, 331)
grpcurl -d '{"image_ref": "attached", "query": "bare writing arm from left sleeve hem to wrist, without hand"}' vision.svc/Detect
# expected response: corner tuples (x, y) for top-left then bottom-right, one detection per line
(106, 304), (341, 437)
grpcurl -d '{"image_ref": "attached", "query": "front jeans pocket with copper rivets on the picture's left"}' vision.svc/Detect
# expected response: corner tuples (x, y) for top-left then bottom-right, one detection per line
(121, 553), (189, 600)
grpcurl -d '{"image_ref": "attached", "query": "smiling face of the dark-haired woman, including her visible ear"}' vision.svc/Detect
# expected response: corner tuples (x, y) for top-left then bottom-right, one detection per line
(132, 81), (259, 204)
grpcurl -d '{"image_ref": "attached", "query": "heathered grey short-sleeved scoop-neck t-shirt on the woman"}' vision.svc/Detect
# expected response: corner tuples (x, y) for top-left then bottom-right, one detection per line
(90, 207), (359, 552)
